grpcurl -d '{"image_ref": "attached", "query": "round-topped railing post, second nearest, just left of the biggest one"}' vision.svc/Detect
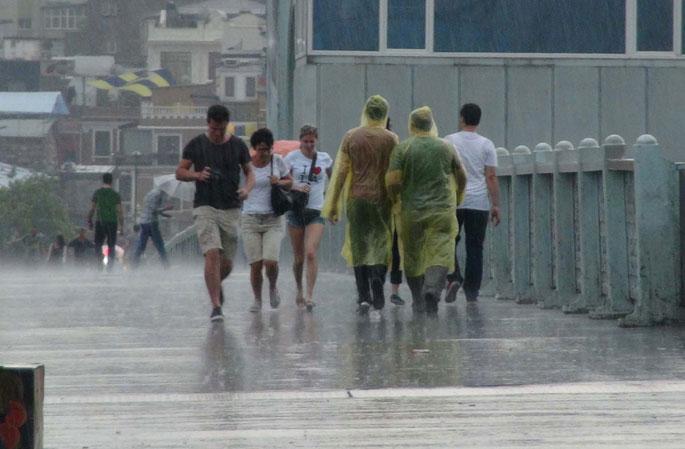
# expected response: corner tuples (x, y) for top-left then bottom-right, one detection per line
(590, 135), (633, 319)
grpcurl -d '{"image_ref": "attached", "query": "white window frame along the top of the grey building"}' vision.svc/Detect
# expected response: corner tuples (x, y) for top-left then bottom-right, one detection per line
(308, 0), (685, 60)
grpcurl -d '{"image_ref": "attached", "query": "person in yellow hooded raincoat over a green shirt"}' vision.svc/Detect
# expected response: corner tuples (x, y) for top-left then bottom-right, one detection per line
(385, 106), (466, 313)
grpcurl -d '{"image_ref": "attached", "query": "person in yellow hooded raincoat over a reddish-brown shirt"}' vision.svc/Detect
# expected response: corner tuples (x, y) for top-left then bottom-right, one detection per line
(322, 95), (399, 314)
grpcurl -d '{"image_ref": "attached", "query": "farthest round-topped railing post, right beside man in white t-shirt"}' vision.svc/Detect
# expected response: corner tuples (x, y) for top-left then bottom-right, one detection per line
(490, 148), (514, 300)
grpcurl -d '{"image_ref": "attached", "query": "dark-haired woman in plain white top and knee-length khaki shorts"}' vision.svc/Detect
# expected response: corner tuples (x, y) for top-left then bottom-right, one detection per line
(240, 128), (293, 313)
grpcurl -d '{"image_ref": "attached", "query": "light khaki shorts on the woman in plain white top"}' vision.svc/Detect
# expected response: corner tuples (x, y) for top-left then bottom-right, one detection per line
(240, 214), (284, 264)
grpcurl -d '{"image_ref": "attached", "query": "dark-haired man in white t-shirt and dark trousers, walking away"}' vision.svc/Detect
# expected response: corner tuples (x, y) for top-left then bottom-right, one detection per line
(445, 103), (500, 303)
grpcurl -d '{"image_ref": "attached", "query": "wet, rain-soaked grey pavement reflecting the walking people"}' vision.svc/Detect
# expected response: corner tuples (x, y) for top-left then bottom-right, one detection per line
(0, 266), (685, 449)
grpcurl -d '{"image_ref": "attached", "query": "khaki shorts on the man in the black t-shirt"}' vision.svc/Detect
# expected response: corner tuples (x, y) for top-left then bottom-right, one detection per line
(193, 206), (240, 259)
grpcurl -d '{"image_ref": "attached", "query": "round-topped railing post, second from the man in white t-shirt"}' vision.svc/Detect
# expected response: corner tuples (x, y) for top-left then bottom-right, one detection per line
(511, 145), (534, 304)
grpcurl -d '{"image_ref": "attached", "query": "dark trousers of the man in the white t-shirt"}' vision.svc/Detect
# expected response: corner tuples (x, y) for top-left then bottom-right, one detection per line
(447, 209), (490, 298)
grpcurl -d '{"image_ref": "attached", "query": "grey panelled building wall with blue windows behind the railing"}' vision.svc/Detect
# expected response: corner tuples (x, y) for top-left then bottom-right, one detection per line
(268, 0), (685, 160)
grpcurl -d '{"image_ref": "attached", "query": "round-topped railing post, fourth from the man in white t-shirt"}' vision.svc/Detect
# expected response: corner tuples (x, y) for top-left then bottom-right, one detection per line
(554, 141), (578, 308)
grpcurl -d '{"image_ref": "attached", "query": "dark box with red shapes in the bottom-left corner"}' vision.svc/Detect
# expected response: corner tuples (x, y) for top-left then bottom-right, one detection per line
(0, 365), (45, 449)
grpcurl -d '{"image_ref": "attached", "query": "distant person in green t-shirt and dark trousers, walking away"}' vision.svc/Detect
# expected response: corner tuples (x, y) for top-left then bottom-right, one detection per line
(88, 173), (124, 270)
